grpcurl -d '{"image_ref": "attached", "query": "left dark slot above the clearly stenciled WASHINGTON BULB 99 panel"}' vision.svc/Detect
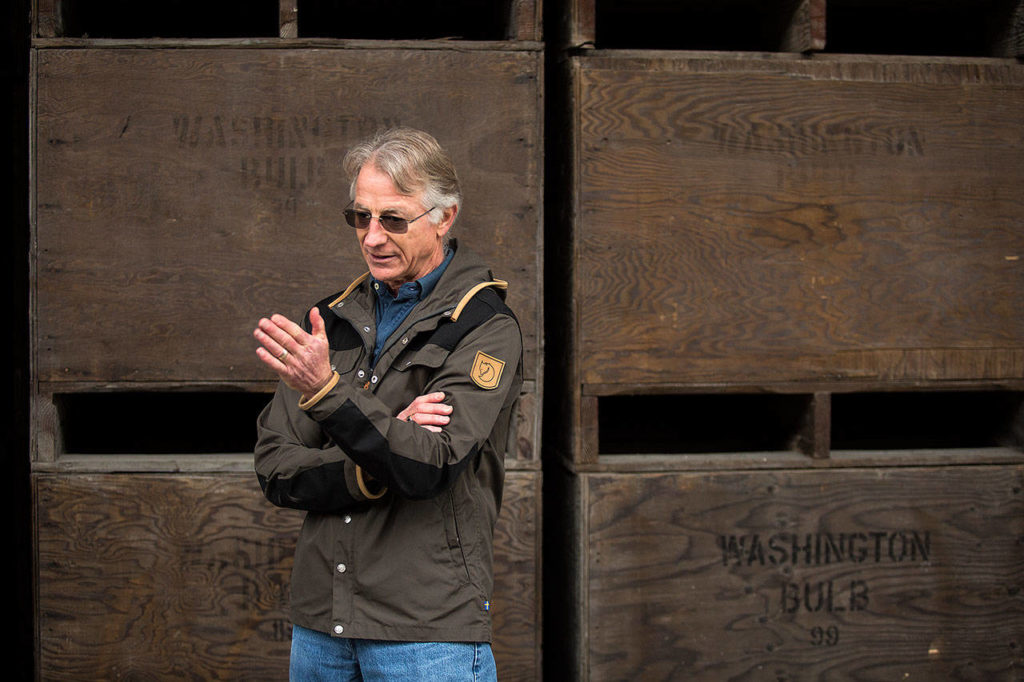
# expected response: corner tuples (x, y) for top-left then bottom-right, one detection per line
(598, 394), (812, 455)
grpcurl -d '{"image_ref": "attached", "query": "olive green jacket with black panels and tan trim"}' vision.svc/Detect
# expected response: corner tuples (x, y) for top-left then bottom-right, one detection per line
(255, 243), (522, 642)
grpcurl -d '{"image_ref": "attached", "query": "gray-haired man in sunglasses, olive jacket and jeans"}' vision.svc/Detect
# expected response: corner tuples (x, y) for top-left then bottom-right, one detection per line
(254, 128), (522, 681)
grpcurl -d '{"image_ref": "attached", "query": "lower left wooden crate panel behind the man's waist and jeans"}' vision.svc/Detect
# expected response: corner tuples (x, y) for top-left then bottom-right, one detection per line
(34, 473), (540, 681)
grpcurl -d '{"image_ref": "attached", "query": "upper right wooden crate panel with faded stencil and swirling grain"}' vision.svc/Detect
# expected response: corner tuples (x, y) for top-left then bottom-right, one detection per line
(572, 52), (1024, 385)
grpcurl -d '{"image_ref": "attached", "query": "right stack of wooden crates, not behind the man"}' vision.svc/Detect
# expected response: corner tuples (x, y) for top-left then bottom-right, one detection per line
(545, 0), (1024, 680)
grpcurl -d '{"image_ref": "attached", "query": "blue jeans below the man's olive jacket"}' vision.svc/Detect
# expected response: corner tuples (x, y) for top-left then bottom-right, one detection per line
(289, 626), (498, 682)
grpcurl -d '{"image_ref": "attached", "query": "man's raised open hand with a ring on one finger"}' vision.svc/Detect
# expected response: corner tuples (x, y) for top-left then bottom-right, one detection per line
(253, 307), (334, 399)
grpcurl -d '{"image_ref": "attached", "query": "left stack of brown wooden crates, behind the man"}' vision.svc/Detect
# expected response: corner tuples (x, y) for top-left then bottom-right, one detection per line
(31, 0), (544, 680)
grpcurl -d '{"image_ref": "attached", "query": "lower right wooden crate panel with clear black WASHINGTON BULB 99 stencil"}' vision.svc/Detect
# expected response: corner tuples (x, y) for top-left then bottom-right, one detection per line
(578, 466), (1024, 681)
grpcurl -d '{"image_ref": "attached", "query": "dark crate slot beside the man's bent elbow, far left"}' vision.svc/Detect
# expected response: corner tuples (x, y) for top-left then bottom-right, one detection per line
(53, 391), (270, 455)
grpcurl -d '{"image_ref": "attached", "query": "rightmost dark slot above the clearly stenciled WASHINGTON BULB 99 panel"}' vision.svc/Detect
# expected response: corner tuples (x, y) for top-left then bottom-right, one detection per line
(831, 391), (1024, 451)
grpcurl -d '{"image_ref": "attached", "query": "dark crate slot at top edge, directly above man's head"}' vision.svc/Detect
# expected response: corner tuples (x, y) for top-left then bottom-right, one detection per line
(297, 0), (515, 40)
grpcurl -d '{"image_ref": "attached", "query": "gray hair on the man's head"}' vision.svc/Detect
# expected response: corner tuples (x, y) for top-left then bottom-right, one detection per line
(343, 128), (462, 229)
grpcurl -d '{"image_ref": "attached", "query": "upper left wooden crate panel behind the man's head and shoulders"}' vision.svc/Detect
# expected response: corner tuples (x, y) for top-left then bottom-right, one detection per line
(33, 46), (542, 382)
